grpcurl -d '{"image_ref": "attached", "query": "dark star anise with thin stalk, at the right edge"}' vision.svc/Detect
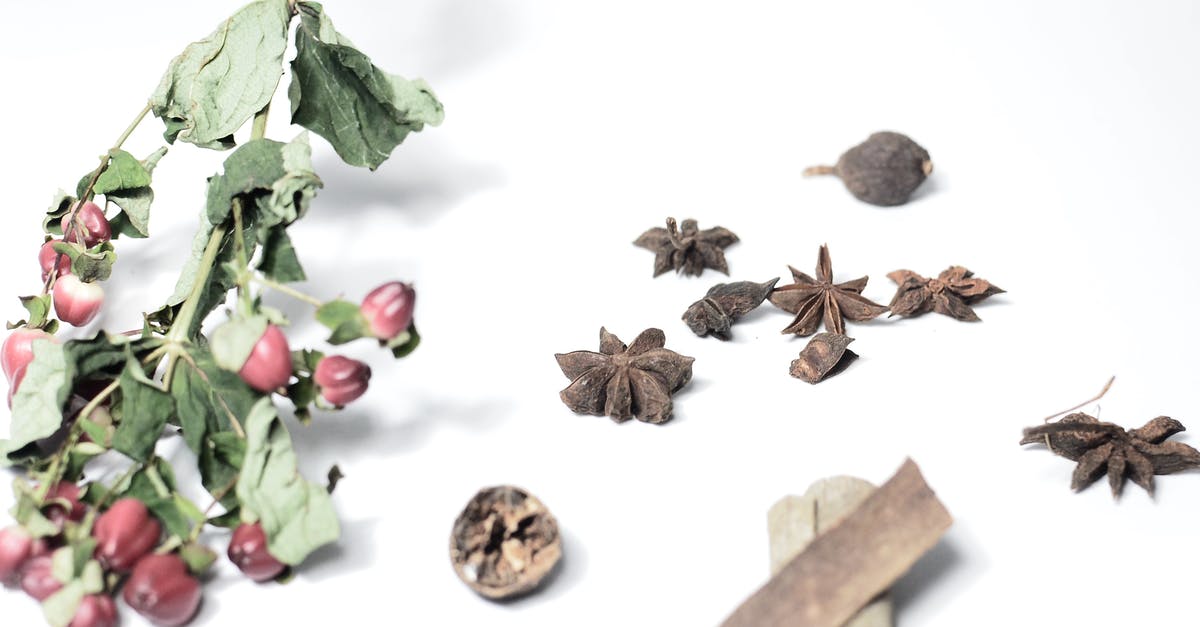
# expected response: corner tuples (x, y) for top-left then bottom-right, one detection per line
(1021, 413), (1200, 498)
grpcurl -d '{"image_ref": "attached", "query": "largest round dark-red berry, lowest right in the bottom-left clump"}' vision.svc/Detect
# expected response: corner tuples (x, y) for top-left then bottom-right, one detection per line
(122, 554), (200, 627)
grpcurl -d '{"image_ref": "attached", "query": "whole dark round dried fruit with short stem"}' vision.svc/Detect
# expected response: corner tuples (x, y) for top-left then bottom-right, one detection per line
(804, 131), (934, 207)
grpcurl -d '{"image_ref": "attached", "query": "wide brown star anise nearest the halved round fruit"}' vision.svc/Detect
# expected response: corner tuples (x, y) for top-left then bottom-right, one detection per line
(554, 327), (695, 423)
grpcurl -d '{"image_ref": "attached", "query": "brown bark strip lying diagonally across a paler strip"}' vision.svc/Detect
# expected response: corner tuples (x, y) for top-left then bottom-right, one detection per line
(721, 459), (952, 627)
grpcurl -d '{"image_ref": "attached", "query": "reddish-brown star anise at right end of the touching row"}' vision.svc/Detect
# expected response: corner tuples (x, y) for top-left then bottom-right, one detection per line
(888, 265), (1004, 322)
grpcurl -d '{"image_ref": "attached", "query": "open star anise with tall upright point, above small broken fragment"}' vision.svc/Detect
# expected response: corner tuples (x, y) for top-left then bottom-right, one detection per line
(770, 245), (888, 336)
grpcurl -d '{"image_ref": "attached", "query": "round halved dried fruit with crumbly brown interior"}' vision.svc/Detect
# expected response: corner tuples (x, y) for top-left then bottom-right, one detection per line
(450, 485), (563, 599)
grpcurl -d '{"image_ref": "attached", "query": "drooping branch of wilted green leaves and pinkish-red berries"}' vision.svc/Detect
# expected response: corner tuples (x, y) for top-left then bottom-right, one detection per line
(0, 0), (443, 627)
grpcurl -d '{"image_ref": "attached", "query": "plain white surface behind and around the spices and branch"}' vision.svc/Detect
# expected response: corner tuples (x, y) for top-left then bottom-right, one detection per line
(0, 0), (1200, 627)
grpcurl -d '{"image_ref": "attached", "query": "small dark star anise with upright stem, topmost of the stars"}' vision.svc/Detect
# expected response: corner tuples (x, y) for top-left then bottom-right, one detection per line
(634, 217), (738, 276)
